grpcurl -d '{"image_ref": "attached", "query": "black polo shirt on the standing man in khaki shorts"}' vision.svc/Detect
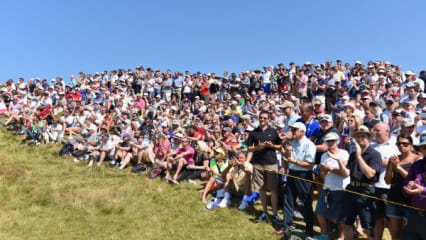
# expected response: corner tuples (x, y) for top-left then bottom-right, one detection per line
(247, 127), (281, 165)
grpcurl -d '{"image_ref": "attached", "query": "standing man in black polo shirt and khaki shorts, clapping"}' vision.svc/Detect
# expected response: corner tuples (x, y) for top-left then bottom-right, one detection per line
(247, 111), (281, 223)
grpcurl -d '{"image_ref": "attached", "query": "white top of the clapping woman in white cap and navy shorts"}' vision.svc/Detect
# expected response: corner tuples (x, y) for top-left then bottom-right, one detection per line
(321, 149), (350, 191)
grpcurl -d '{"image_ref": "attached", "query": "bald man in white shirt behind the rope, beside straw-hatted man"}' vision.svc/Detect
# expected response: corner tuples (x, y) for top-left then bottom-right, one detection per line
(372, 122), (400, 239)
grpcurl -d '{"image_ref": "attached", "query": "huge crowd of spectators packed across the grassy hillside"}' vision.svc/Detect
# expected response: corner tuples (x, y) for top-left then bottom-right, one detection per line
(0, 60), (426, 239)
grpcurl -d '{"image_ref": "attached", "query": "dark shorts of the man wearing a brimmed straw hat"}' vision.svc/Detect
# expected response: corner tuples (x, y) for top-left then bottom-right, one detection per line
(338, 185), (375, 230)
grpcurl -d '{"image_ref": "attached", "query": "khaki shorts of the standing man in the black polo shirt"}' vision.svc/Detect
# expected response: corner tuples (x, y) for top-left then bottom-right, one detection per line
(252, 164), (280, 192)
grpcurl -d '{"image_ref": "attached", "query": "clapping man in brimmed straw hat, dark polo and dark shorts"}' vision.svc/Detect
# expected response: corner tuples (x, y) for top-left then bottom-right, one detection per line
(339, 125), (382, 239)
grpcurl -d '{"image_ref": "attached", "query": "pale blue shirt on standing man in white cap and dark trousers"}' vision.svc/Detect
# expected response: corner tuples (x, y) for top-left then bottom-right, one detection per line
(289, 137), (317, 171)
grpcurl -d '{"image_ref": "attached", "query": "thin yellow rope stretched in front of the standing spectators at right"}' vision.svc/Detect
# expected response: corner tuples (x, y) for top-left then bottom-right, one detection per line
(253, 165), (426, 212)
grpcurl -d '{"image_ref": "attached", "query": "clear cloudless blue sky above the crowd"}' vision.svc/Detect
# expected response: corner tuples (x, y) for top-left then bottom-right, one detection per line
(0, 0), (426, 82)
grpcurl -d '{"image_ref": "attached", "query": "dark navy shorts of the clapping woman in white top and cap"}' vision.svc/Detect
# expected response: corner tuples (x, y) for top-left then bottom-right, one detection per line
(315, 189), (345, 219)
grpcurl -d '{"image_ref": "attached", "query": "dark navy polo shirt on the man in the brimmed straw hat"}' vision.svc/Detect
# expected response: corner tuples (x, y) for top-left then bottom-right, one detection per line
(347, 146), (382, 184)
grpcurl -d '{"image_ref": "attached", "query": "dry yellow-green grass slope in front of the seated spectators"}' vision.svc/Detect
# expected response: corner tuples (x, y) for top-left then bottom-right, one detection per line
(0, 129), (390, 240)
